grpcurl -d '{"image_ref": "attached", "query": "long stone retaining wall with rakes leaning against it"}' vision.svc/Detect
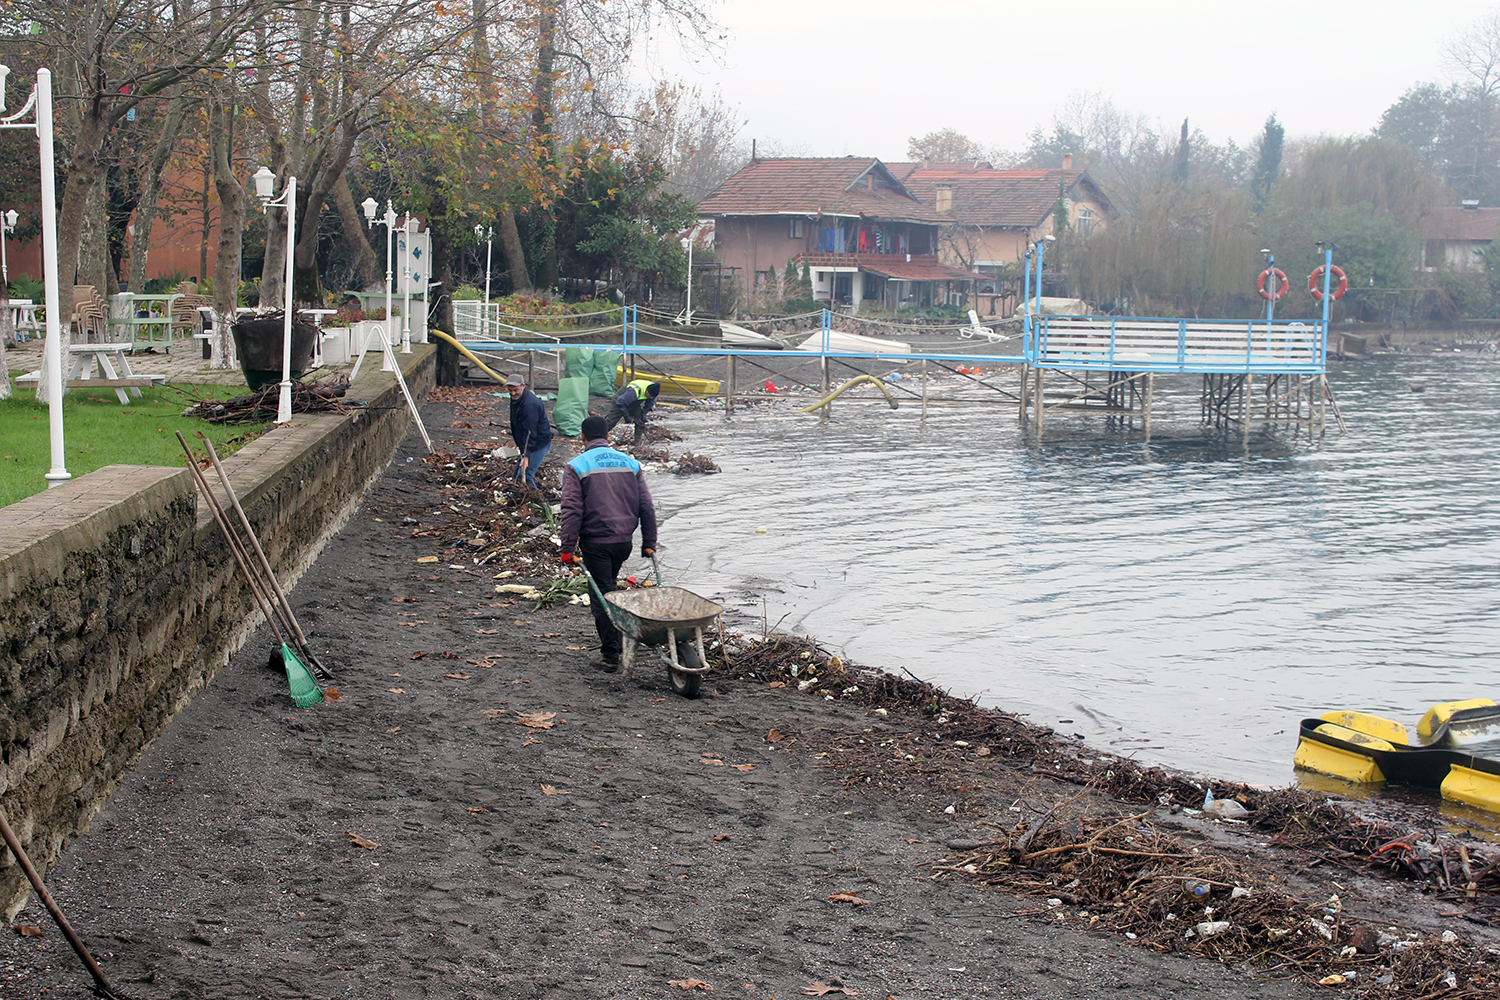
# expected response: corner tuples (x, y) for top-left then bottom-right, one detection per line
(0, 346), (437, 919)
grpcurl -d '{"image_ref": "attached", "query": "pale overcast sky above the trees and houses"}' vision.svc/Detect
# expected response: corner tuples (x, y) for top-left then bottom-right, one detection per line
(651, 0), (1494, 160)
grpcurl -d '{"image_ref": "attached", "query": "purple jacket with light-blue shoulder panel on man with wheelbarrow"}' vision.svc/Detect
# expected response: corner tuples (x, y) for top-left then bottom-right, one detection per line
(560, 438), (656, 552)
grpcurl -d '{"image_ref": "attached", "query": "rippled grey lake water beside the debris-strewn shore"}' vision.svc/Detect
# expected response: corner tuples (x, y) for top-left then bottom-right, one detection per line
(651, 352), (1500, 786)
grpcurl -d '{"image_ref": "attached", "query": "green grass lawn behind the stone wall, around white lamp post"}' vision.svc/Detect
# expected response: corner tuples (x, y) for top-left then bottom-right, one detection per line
(0, 385), (270, 507)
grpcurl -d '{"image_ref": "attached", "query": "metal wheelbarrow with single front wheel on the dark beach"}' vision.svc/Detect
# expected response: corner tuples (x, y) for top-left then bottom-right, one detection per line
(579, 555), (725, 699)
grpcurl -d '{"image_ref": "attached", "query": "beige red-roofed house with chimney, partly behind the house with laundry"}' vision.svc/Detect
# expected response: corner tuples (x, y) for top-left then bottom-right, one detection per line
(891, 156), (1119, 315)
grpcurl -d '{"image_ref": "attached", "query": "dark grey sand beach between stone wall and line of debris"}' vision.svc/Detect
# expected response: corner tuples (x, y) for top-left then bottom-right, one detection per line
(0, 389), (1472, 1000)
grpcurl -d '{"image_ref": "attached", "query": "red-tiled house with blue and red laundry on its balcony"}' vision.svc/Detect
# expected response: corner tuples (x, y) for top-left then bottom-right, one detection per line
(698, 156), (980, 310)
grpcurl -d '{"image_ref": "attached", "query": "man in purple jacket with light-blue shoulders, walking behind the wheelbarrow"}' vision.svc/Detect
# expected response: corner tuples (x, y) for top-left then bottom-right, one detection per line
(560, 417), (657, 673)
